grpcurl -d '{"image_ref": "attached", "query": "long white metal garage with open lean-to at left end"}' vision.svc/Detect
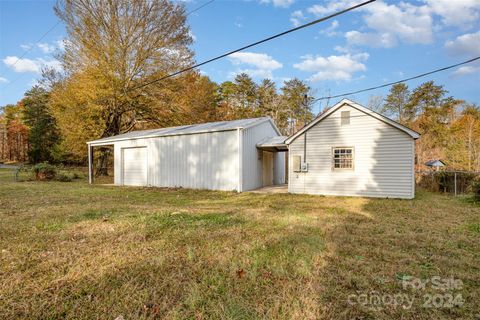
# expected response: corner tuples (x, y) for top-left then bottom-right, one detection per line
(88, 117), (285, 192)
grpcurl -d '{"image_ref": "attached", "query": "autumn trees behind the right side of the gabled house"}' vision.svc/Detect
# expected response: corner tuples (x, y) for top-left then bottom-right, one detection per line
(383, 81), (480, 171)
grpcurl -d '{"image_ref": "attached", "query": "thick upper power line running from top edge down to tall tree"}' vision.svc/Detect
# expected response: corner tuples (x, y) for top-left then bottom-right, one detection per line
(127, 0), (376, 91)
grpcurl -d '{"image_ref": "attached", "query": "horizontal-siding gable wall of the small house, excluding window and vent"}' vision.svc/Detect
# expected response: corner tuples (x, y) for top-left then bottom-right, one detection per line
(289, 106), (414, 198)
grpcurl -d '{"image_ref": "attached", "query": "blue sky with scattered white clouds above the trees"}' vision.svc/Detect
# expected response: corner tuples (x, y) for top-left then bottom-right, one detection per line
(0, 0), (480, 112)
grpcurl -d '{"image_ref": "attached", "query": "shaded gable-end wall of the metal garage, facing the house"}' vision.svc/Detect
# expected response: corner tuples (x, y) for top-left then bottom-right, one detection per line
(241, 121), (285, 191)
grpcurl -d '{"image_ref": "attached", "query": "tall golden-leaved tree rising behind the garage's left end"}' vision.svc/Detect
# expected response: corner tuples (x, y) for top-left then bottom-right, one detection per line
(51, 0), (192, 173)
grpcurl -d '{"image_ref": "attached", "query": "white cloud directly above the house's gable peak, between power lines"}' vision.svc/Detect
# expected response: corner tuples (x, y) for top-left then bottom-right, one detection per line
(293, 53), (368, 81)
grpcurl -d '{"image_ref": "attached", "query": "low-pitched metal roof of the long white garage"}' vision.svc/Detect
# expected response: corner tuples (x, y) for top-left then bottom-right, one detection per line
(87, 117), (278, 145)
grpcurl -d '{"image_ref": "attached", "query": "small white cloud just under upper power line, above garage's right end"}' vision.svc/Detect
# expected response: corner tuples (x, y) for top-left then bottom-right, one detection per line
(229, 52), (283, 78)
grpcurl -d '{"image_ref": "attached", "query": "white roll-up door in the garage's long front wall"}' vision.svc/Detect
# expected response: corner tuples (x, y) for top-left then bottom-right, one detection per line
(122, 147), (148, 186)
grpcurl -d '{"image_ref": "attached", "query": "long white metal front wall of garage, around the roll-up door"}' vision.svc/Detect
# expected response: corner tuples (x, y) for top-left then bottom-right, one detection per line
(115, 130), (239, 191)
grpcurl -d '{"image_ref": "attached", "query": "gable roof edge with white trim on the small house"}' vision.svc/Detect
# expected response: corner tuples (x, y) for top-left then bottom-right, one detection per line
(285, 99), (420, 144)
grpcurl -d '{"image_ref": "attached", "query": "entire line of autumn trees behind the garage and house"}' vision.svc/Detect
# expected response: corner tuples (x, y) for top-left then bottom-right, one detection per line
(0, 0), (480, 174)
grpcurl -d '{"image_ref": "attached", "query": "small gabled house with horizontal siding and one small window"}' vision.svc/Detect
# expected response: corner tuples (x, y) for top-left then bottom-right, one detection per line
(285, 99), (420, 199)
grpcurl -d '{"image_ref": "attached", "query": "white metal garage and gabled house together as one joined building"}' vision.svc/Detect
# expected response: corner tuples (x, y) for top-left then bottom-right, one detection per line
(88, 99), (419, 199)
